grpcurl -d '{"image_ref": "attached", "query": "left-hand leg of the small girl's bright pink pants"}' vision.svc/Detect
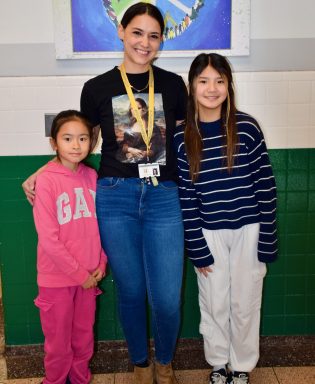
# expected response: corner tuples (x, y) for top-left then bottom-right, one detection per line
(35, 287), (76, 384)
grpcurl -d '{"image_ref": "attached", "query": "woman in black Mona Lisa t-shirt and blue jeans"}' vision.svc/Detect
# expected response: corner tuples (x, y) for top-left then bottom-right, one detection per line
(23, 2), (190, 384)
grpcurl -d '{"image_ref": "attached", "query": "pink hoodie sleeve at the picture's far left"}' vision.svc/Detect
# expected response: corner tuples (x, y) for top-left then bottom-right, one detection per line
(33, 176), (90, 285)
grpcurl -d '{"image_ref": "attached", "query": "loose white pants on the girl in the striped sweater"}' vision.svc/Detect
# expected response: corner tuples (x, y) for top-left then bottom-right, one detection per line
(195, 224), (266, 372)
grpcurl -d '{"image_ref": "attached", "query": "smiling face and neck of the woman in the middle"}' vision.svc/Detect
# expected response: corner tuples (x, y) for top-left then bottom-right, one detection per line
(118, 14), (162, 73)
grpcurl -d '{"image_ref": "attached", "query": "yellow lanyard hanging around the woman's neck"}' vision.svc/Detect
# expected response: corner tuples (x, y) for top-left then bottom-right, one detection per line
(120, 64), (154, 158)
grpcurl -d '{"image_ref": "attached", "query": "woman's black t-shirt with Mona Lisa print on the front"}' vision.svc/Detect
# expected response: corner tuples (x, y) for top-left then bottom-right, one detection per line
(81, 66), (187, 181)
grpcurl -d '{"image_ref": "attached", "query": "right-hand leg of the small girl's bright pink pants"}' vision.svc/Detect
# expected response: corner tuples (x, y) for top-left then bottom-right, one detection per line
(69, 287), (100, 384)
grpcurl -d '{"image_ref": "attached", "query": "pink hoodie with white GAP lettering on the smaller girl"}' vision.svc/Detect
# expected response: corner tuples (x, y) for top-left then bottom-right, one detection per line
(33, 162), (107, 287)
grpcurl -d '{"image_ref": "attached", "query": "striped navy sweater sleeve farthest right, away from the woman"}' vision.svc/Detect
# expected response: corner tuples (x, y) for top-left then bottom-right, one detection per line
(249, 122), (278, 262)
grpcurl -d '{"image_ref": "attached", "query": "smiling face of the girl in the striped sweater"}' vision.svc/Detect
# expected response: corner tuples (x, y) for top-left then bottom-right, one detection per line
(194, 65), (228, 122)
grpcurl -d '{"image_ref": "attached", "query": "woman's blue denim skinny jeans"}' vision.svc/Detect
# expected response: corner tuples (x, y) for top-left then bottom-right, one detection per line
(96, 177), (184, 364)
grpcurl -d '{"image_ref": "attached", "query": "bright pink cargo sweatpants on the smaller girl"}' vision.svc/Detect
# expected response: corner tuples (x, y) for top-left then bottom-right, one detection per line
(34, 286), (101, 384)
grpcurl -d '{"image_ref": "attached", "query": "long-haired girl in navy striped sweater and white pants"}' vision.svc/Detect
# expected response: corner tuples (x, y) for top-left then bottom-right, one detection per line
(175, 53), (277, 384)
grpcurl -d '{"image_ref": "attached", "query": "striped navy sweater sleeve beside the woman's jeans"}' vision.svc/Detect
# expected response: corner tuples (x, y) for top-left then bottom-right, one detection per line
(174, 128), (214, 268)
